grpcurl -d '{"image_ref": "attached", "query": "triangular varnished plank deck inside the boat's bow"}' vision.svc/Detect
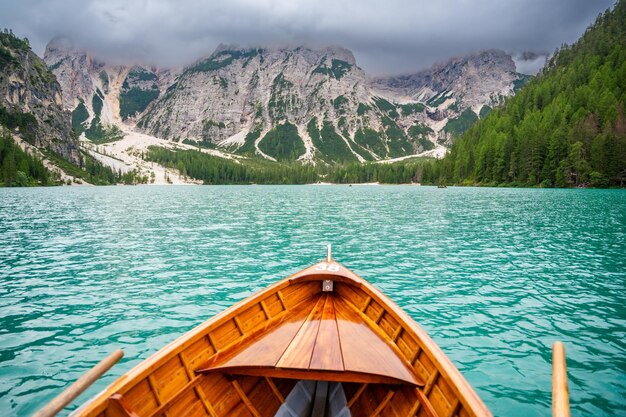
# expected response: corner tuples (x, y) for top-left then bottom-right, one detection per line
(197, 293), (424, 386)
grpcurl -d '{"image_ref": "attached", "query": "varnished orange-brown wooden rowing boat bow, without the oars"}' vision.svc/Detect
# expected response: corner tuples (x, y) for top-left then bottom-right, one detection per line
(67, 255), (491, 417)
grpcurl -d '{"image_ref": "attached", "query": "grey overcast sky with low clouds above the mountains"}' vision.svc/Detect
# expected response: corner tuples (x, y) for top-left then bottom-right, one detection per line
(0, 0), (614, 75)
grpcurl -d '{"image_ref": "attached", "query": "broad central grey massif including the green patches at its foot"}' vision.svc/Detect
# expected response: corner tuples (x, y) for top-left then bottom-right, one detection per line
(138, 46), (408, 162)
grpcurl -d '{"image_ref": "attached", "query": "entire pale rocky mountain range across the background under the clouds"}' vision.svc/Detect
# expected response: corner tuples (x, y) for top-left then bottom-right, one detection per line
(45, 40), (525, 164)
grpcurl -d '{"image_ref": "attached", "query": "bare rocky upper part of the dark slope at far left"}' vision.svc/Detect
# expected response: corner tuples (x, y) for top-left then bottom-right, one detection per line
(0, 32), (79, 163)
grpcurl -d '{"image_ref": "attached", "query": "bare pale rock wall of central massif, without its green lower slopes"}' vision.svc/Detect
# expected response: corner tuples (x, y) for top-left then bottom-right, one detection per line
(138, 45), (370, 160)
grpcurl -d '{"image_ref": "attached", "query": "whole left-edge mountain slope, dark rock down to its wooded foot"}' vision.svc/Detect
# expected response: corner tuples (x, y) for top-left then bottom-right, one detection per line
(0, 29), (163, 186)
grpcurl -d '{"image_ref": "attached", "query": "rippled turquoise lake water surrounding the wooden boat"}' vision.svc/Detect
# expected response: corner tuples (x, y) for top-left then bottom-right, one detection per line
(0, 186), (626, 416)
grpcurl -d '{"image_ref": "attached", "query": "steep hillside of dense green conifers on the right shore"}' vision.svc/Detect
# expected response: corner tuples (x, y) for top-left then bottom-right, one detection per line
(422, 0), (626, 187)
